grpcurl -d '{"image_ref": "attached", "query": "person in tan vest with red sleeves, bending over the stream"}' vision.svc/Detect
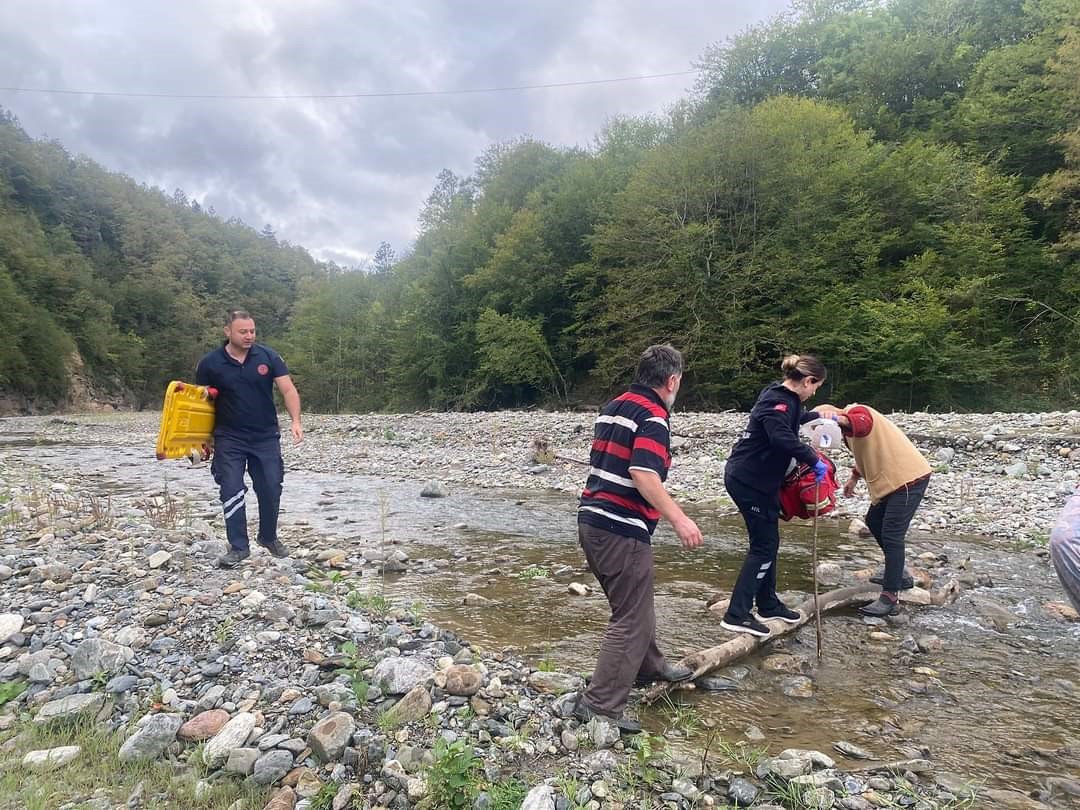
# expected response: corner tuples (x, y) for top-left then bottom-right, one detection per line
(819, 404), (930, 617)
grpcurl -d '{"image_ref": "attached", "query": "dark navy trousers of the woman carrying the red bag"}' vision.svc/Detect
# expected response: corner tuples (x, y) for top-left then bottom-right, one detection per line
(724, 475), (781, 621)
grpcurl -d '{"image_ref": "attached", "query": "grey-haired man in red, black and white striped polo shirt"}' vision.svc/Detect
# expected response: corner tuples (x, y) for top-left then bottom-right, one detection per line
(575, 343), (701, 733)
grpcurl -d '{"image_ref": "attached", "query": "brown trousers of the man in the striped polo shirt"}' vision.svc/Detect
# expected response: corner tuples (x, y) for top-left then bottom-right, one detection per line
(578, 524), (664, 717)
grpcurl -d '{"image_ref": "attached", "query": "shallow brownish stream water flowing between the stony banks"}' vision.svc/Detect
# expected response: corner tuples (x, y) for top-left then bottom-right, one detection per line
(4, 444), (1080, 789)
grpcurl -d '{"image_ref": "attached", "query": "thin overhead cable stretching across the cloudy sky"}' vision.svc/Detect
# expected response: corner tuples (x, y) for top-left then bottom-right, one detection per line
(0, 70), (697, 102)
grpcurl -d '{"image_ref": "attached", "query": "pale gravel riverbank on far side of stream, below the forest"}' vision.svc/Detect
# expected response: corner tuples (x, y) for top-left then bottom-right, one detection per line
(8, 410), (1080, 542)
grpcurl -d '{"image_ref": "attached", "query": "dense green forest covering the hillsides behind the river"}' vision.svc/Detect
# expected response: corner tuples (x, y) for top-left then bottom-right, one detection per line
(0, 0), (1080, 413)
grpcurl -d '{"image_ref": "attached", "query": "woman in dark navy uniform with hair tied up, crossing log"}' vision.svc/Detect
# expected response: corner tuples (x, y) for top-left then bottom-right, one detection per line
(720, 354), (828, 636)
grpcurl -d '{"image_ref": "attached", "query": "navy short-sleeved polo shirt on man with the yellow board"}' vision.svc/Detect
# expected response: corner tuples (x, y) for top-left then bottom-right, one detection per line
(195, 343), (288, 438)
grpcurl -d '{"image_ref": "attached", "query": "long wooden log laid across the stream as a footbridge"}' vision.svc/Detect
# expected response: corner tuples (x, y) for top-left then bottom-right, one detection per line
(642, 579), (960, 704)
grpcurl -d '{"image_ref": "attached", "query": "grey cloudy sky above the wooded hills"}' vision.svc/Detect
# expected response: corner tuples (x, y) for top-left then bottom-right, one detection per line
(0, 0), (787, 265)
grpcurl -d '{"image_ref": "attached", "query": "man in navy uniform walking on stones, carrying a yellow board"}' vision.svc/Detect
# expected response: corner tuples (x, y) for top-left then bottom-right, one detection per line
(195, 310), (303, 568)
